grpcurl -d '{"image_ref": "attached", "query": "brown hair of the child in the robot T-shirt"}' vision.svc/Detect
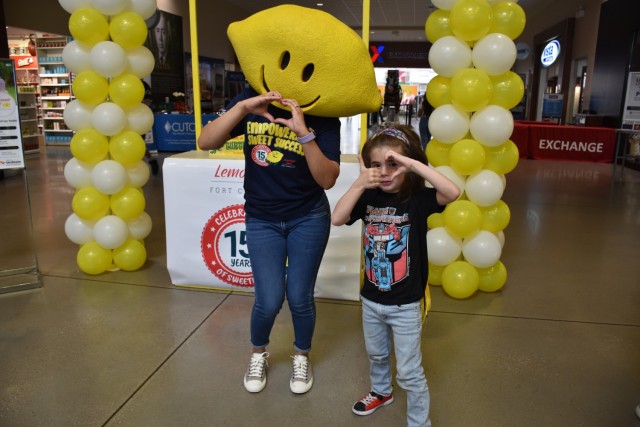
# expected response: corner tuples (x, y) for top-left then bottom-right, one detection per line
(362, 125), (427, 203)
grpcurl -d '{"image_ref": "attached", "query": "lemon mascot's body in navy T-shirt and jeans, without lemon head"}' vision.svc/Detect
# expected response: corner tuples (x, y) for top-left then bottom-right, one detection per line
(198, 88), (340, 394)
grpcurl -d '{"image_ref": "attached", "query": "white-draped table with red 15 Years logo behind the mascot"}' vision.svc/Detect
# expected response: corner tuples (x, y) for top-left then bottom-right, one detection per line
(162, 151), (362, 301)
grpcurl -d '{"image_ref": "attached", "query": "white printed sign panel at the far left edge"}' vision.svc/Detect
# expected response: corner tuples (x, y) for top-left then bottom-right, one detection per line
(0, 59), (24, 170)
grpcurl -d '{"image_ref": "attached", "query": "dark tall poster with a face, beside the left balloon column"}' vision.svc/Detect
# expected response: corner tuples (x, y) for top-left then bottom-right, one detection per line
(145, 9), (184, 106)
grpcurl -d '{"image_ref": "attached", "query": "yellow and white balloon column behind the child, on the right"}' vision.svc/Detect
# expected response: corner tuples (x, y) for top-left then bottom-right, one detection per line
(425, 0), (525, 298)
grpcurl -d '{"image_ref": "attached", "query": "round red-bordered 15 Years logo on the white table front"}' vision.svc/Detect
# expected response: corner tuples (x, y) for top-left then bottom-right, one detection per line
(200, 205), (253, 287)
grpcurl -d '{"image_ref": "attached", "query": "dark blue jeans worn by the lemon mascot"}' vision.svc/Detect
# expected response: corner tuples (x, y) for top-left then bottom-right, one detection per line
(246, 196), (331, 352)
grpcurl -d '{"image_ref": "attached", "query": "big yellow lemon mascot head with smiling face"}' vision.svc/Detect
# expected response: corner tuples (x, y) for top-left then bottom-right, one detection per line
(227, 5), (382, 117)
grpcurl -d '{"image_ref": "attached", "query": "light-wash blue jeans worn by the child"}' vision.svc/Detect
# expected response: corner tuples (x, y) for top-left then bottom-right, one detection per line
(362, 298), (431, 427)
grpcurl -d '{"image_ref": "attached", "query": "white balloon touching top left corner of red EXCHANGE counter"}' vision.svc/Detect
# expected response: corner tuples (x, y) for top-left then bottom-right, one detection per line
(469, 105), (513, 147)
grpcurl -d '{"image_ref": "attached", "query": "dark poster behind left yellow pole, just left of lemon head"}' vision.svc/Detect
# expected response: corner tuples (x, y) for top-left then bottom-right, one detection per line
(184, 52), (225, 114)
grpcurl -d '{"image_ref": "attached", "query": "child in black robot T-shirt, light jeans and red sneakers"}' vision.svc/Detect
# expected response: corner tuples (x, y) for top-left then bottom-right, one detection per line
(331, 126), (460, 426)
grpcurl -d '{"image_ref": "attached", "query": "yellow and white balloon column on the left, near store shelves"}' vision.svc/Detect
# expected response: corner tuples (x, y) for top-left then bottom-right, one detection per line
(59, 0), (156, 274)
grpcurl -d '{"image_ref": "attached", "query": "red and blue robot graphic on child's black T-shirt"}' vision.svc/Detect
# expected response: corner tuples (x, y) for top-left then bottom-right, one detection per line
(364, 222), (409, 292)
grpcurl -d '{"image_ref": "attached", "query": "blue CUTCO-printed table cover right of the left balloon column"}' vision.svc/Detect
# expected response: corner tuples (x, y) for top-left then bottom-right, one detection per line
(153, 114), (218, 151)
